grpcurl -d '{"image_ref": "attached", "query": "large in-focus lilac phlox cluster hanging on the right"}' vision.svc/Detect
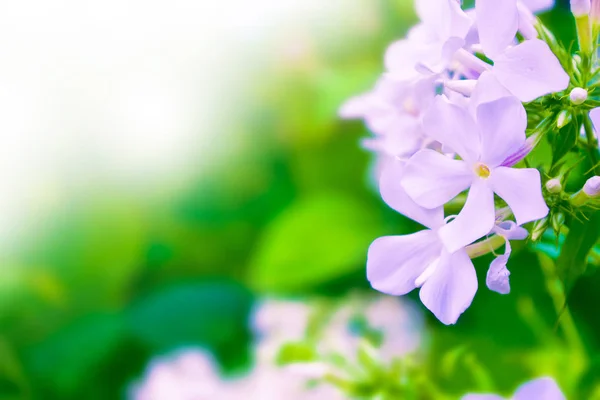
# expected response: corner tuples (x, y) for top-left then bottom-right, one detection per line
(340, 0), (570, 324)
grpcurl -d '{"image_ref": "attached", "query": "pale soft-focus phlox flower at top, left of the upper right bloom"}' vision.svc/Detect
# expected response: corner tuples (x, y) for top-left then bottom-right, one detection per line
(385, 0), (473, 81)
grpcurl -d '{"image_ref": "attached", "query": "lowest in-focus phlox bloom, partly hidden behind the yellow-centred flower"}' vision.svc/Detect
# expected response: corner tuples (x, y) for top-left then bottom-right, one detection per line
(367, 161), (477, 325)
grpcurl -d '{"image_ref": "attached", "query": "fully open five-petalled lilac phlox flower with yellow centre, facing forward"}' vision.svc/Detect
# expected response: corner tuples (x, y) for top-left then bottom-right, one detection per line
(400, 92), (548, 253)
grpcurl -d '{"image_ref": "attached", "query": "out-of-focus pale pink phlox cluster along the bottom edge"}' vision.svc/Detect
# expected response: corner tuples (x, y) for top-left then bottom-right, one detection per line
(129, 297), (423, 400)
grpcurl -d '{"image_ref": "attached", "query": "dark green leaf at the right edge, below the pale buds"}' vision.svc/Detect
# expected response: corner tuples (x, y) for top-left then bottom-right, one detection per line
(556, 212), (600, 291)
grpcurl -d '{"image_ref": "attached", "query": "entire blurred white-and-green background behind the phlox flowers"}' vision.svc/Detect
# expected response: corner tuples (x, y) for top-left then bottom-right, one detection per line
(0, 0), (600, 400)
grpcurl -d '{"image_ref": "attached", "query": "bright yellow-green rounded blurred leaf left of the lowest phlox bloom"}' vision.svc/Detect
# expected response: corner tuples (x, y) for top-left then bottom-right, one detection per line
(250, 194), (379, 291)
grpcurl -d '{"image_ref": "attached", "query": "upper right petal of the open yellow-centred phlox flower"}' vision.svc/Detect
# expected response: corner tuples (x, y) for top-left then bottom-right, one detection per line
(477, 97), (527, 167)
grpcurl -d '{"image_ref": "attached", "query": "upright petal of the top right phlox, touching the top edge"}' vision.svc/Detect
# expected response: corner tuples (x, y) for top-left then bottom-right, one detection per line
(475, 0), (519, 59)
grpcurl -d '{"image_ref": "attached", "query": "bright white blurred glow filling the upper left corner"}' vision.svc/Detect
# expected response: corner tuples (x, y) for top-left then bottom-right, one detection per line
(0, 0), (357, 247)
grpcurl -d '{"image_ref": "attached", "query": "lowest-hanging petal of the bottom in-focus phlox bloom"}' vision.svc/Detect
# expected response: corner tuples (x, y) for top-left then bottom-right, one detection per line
(419, 250), (477, 325)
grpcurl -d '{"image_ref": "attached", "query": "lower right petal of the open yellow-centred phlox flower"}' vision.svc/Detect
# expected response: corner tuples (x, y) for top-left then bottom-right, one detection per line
(490, 167), (548, 225)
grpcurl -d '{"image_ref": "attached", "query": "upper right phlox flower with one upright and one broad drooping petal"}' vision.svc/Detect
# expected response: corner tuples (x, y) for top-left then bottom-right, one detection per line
(468, 0), (569, 101)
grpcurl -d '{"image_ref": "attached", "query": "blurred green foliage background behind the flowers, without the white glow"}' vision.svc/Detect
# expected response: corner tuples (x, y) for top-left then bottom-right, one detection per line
(0, 0), (600, 400)
